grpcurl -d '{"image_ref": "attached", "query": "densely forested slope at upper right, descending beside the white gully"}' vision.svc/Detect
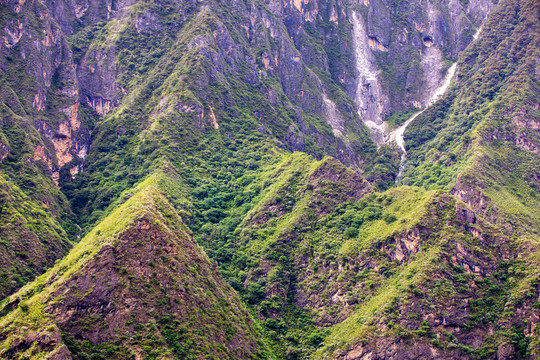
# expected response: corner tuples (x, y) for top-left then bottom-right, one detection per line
(403, 0), (540, 219)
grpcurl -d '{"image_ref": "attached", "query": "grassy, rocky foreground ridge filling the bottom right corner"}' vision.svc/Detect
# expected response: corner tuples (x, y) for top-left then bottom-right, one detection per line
(316, 192), (540, 359)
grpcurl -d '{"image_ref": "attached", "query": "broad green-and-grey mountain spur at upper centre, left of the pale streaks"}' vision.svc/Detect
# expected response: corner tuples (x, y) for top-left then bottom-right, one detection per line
(56, 1), (384, 232)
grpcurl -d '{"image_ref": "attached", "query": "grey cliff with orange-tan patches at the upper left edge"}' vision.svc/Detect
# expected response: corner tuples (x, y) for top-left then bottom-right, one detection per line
(0, 1), (89, 184)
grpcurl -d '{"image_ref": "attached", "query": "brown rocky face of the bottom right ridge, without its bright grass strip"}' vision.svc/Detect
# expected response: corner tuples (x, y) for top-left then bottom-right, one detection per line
(325, 196), (540, 360)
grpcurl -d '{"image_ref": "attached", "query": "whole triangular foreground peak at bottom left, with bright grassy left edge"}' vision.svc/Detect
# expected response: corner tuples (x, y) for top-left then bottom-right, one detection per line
(0, 175), (268, 359)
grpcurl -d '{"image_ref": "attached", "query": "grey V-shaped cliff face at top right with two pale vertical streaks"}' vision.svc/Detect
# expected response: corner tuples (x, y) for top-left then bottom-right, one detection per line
(306, 0), (494, 145)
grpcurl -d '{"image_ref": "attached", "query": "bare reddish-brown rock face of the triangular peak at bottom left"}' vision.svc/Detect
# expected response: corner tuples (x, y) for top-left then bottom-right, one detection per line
(44, 218), (259, 358)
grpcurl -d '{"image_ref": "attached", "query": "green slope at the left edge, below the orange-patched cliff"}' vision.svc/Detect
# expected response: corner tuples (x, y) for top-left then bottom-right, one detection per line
(0, 98), (78, 298)
